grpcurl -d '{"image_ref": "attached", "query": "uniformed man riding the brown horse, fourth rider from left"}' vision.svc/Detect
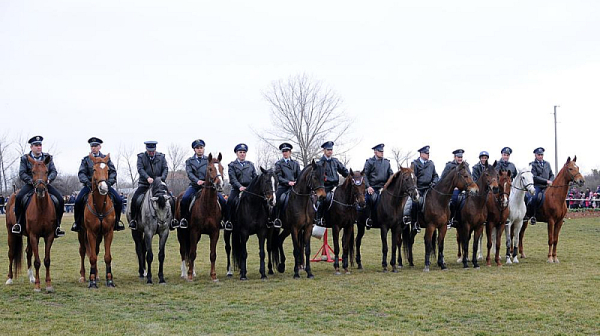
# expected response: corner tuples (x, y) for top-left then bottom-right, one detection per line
(179, 139), (227, 229)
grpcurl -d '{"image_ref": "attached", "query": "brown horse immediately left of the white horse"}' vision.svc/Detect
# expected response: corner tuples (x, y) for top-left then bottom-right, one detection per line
(485, 170), (512, 266)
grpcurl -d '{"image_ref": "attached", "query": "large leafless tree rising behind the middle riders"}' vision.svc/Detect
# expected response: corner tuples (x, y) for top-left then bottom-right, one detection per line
(255, 75), (353, 167)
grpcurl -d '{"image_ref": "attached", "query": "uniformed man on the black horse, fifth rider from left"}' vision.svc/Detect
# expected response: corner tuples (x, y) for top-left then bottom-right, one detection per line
(225, 143), (257, 231)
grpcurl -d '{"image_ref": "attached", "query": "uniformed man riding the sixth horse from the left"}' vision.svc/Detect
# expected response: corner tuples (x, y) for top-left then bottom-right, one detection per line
(273, 142), (300, 228)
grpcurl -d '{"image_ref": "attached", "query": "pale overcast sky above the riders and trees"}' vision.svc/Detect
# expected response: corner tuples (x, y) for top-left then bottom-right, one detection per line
(0, 0), (600, 177)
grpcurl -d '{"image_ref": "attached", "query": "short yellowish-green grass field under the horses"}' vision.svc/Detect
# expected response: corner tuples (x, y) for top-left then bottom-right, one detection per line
(0, 216), (600, 335)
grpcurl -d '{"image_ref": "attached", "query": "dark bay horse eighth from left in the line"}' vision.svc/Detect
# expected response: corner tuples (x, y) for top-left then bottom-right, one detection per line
(356, 168), (419, 272)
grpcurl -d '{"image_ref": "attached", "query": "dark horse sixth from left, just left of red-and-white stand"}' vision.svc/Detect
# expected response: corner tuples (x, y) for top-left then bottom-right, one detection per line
(270, 160), (326, 279)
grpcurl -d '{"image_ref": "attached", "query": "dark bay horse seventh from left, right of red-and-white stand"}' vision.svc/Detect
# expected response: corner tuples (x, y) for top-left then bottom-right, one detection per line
(325, 169), (366, 274)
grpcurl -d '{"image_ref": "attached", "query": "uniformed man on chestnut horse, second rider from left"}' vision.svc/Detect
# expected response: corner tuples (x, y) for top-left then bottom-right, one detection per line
(71, 137), (125, 232)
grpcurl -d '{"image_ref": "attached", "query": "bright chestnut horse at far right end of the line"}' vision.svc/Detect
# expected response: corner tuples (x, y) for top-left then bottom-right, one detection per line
(519, 156), (585, 263)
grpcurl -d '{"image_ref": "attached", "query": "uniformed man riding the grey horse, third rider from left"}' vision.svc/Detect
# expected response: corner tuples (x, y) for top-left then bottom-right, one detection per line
(129, 141), (172, 230)
